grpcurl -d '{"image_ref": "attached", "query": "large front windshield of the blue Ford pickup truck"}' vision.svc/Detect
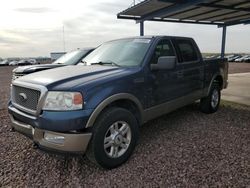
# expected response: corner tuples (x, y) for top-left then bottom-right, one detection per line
(82, 39), (151, 67)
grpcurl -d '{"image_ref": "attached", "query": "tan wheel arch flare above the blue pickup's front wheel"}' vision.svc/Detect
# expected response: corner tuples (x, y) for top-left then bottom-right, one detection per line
(85, 93), (143, 128)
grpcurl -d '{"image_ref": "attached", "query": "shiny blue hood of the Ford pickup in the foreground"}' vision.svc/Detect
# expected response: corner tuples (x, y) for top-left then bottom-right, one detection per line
(14, 65), (129, 89)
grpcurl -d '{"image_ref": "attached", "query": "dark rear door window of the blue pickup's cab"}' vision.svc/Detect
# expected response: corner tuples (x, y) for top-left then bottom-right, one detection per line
(175, 40), (198, 62)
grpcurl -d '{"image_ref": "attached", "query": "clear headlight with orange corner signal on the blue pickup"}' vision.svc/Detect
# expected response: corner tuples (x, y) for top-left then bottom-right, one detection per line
(43, 91), (83, 111)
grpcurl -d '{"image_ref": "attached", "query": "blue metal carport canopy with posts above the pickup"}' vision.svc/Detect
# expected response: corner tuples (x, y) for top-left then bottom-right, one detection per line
(117, 0), (250, 57)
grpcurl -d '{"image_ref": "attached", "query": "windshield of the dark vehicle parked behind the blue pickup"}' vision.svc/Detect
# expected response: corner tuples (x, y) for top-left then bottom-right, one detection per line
(52, 50), (88, 65)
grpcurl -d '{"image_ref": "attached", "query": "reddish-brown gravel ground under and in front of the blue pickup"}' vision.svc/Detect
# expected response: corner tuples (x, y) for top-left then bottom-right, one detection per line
(0, 103), (250, 187)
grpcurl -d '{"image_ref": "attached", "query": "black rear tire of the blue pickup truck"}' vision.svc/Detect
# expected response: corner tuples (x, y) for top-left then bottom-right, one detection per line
(200, 83), (221, 114)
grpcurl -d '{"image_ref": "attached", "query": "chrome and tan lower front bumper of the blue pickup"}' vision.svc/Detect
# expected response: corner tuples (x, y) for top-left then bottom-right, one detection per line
(10, 115), (92, 153)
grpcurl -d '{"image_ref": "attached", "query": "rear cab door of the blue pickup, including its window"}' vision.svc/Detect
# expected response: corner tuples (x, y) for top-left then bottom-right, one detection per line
(173, 38), (204, 95)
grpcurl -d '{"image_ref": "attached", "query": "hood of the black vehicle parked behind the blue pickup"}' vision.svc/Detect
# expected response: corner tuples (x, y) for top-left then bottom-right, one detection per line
(13, 64), (65, 74)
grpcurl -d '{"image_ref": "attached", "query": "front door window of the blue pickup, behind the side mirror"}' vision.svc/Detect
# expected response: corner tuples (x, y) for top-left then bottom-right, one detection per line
(151, 40), (175, 64)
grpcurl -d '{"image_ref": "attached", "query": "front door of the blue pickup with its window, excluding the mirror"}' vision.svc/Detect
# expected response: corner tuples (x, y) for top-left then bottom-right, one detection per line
(148, 39), (185, 107)
